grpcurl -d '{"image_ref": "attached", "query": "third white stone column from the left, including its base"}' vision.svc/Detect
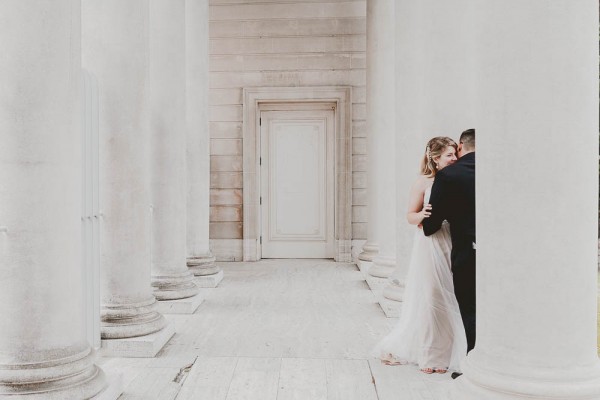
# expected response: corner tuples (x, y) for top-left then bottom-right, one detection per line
(149, 0), (201, 313)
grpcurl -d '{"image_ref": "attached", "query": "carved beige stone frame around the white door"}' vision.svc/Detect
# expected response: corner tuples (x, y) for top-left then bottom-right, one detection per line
(242, 86), (352, 262)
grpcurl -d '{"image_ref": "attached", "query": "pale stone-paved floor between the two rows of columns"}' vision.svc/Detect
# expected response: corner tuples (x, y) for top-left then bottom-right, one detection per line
(98, 260), (453, 400)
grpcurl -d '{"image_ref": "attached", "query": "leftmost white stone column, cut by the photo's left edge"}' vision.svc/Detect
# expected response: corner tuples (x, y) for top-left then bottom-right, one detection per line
(0, 0), (107, 399)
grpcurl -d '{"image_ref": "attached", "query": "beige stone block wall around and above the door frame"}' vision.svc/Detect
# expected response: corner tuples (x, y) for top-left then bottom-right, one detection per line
(209, 0), (367, 260)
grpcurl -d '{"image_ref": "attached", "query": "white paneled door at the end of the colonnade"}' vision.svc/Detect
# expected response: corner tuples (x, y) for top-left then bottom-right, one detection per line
(260, 108), (335, 258)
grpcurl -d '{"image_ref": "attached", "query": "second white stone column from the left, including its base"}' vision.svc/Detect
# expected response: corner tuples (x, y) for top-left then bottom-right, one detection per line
(82, 0), (174, 356)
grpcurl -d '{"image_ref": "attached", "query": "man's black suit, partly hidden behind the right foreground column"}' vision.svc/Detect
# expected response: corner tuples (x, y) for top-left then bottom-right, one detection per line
(423, 152), (475, 351)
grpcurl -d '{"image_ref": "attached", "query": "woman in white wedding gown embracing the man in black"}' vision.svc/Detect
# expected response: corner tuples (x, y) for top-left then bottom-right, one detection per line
(373, 136), (467, 374)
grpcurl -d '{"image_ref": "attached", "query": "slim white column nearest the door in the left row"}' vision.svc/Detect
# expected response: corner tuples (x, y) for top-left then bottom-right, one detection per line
(185, 0), (223, 287)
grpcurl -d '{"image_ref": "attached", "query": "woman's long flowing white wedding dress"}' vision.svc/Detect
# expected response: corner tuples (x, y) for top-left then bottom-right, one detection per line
(373, 188), (467, 371)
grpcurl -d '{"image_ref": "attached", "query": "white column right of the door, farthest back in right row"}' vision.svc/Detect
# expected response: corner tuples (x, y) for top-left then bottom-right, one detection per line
(359, 0), (396, 278)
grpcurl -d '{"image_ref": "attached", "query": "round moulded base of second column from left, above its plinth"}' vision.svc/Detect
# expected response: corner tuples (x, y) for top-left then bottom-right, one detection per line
(100, 296), (167, 339)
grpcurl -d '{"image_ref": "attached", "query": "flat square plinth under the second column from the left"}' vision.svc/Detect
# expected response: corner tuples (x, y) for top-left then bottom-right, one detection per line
(99, 325), (175, 358)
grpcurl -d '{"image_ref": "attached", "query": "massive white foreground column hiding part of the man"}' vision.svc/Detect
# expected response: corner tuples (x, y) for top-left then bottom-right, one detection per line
(453, 0), (600, 400)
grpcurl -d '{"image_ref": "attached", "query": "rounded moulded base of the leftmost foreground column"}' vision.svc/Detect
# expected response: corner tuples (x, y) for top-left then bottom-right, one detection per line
(0, 347), (108, 400)
